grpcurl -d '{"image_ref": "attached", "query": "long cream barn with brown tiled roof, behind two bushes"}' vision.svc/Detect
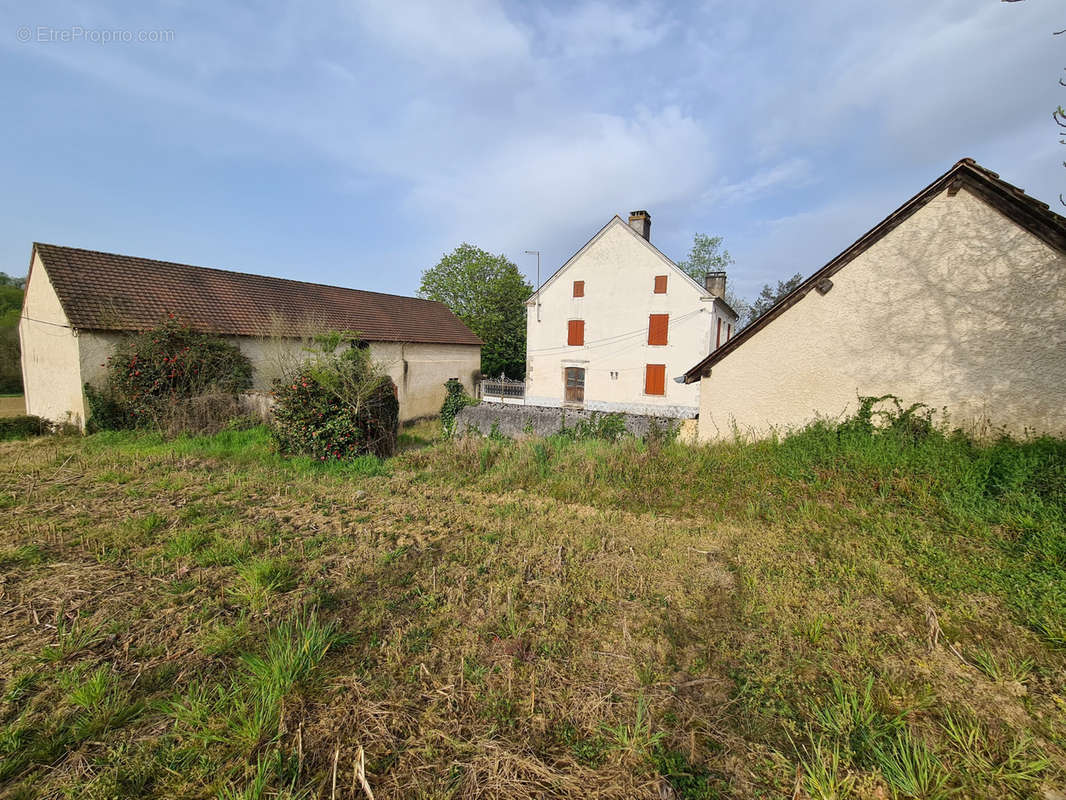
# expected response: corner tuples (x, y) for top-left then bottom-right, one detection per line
(19, 243), (481, 426)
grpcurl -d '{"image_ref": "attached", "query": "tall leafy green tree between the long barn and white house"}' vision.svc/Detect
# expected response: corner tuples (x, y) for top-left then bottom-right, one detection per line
(418, 242), (533, 378)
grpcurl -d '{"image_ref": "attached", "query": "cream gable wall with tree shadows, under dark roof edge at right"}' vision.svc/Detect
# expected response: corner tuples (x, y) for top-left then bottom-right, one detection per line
(690, 189), (1066, 441)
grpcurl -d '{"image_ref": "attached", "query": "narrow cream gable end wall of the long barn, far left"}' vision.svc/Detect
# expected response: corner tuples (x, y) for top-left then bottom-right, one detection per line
(18, 260), (85, 425)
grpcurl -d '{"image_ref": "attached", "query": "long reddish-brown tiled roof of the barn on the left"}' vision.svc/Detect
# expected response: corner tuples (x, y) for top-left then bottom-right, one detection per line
(33, 243), (482, 345)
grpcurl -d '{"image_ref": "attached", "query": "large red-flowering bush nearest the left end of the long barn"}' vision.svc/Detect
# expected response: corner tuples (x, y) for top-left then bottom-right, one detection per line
(86, 317), (252, 428)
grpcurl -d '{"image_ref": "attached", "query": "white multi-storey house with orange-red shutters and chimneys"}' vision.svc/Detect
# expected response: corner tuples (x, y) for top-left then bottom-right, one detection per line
(526, 211), (737, 418)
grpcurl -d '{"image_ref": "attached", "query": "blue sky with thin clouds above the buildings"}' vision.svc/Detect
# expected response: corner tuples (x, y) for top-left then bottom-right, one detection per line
(0, 0), (1066, 298)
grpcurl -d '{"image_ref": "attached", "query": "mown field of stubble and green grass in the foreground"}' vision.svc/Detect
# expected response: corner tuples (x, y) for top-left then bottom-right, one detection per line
(0, 427), (1066, 800)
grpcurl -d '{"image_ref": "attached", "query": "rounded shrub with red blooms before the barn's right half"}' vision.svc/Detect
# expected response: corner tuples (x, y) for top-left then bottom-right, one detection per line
(272, 347), (400, 461)
